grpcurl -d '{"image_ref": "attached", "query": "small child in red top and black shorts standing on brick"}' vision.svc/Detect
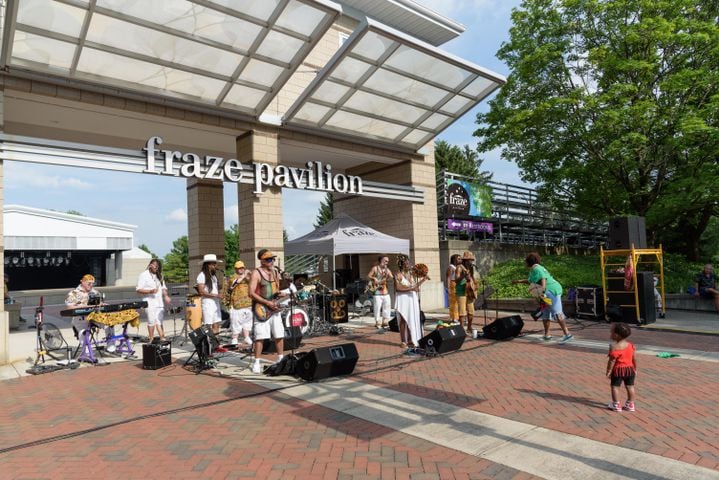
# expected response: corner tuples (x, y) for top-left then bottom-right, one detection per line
(607, 323), (637, 412)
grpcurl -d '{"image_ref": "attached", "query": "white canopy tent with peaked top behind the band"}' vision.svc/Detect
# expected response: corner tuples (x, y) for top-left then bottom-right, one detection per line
(285, 214), (409, 288)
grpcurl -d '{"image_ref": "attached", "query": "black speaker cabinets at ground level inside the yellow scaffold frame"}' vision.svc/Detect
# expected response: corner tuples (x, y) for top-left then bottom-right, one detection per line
(607, 272), (657, 325)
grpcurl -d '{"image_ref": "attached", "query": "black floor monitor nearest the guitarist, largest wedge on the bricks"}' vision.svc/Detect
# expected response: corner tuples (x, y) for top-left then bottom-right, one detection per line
(296, 343), (359, 381)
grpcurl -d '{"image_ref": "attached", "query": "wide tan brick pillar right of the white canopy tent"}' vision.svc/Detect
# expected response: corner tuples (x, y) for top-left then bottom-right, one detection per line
(334, 144), (444, 310)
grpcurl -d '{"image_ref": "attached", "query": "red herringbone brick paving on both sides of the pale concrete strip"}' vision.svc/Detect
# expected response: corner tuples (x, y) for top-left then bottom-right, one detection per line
(0, 322), (719, 479)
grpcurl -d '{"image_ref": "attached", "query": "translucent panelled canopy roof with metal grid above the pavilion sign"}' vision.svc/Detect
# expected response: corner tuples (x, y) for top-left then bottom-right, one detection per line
(0, 0), (504, 150)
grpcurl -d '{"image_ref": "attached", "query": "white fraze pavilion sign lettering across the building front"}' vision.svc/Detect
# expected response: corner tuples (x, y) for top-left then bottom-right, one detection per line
(142, 137), (362, 195)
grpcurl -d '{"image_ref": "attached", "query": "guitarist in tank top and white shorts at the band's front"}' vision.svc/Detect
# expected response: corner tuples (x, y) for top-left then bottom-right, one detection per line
(250, 248), (285, 373)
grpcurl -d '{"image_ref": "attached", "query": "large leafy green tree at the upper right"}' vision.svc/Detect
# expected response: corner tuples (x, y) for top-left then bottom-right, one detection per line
(475, 0), (719, 259)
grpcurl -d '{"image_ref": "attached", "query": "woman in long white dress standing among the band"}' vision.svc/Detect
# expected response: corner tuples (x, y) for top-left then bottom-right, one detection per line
(394, 255), (425, 349)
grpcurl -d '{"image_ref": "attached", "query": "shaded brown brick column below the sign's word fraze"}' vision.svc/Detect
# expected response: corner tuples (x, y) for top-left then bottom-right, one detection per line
(187, 178), (225, 286)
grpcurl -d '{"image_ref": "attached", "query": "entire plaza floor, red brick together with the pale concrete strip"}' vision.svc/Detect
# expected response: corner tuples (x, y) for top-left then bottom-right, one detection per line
(0, 314), (719, 480)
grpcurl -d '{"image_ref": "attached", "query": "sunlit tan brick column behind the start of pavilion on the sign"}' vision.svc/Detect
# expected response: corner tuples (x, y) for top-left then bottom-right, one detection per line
(237, 127), (284, 268)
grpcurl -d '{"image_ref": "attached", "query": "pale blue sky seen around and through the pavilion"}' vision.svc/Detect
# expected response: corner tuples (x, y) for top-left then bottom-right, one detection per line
(4, 0), (521, 257)
